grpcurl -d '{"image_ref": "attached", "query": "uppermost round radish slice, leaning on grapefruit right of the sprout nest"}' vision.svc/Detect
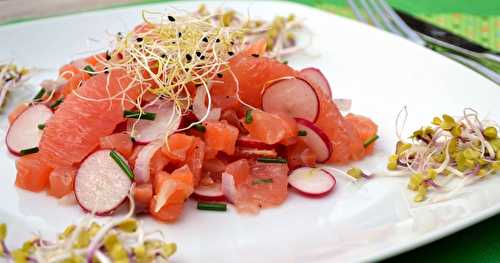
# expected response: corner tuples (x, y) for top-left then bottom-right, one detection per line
(262, 78), (319, 122)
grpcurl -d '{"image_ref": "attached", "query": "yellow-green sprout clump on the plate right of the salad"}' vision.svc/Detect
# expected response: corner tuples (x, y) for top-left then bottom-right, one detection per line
(387, 108), (500, 202)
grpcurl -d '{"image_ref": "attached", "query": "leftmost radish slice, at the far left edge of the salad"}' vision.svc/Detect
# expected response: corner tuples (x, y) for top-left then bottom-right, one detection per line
(5, 104), (53, 155)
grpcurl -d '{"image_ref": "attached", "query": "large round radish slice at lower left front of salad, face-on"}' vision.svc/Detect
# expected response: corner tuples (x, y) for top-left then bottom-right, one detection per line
(75, 150), (132, 215)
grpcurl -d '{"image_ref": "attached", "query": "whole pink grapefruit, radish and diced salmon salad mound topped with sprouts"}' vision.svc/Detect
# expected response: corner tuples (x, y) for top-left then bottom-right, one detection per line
(6, 9), (377, 222)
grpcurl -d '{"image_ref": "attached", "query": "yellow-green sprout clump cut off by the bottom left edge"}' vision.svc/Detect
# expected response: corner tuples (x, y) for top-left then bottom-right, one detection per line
(0, 196), (177, 263)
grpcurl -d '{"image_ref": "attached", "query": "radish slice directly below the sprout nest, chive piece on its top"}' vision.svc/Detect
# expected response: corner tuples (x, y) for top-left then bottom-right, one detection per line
(127, 100), (181, 143)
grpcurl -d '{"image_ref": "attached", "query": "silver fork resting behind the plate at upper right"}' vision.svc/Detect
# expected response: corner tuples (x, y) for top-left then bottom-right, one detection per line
(347, 0), (500, 85)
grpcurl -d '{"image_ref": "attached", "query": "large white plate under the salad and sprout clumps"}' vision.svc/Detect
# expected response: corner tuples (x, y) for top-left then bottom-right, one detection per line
(0, 1), (500, 262)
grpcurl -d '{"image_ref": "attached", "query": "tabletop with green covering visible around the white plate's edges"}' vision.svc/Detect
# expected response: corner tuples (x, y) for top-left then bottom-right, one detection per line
(0, 0), (500, 263)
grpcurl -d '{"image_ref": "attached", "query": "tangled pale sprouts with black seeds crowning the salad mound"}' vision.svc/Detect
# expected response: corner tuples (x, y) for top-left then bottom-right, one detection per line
(75, 5), (303, 139)
